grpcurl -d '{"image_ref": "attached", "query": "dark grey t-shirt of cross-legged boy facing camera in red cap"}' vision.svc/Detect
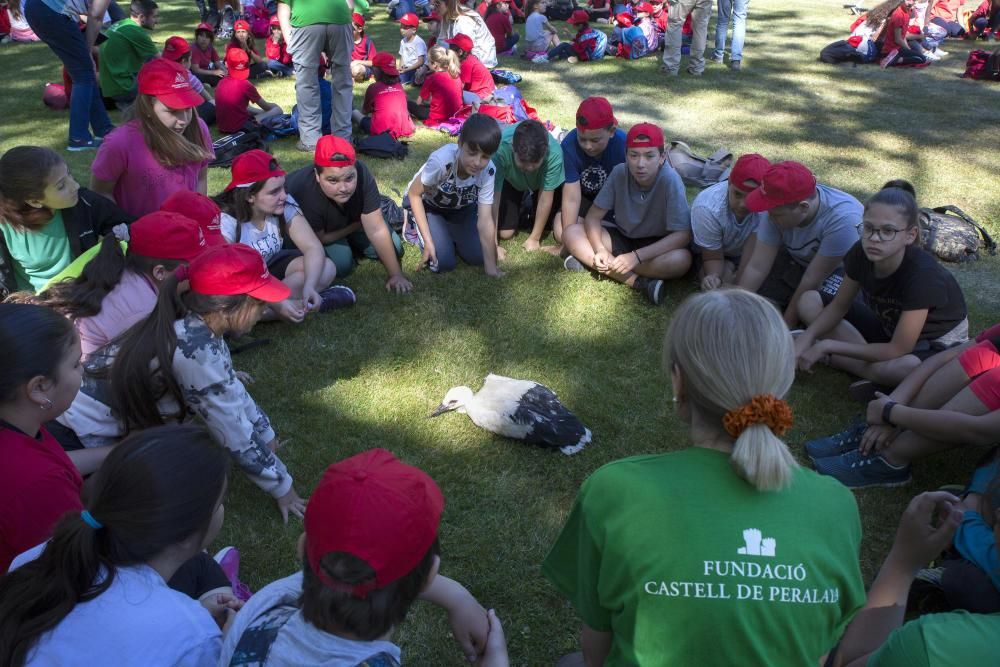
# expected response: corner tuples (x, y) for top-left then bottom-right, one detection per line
(594, 162), (691, 239)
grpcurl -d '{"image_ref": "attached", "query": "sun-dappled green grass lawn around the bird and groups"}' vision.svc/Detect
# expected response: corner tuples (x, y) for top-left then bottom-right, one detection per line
(0, 0), (1000, 665)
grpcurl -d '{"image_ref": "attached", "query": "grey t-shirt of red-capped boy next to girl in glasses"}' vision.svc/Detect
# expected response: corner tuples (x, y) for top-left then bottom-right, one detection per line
(757, 185), (864, 266)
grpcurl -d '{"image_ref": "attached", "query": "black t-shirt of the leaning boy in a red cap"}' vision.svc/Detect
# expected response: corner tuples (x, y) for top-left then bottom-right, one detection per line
(285, 162), (382, 234)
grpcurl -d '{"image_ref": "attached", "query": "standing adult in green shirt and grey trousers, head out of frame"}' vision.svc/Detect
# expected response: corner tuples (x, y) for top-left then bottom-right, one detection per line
(280, 0), (354, 153)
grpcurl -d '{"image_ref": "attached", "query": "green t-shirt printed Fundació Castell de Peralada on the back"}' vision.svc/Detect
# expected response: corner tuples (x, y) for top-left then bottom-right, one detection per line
(542, 447), (865, 667)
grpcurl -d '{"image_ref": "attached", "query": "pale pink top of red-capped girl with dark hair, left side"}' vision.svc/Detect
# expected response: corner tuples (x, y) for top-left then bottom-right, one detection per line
(73, 270), (156, 357)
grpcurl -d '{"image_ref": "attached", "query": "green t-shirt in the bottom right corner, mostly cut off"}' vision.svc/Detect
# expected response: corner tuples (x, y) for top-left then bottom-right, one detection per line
(868, 611), (1000, 667)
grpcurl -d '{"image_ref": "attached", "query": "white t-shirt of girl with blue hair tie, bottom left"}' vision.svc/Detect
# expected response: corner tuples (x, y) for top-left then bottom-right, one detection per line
(14, 545), (222, 667)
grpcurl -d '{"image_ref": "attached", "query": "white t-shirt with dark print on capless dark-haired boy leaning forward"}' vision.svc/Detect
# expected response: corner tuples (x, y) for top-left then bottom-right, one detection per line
(407, 144), (496, 211)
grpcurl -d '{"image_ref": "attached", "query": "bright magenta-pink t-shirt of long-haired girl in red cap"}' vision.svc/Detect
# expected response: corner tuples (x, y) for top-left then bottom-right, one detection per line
(90, 118), (212, 218)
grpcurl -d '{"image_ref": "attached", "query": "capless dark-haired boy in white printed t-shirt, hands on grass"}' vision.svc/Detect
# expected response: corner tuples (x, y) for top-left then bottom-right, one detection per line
(406, 114), (500, 276)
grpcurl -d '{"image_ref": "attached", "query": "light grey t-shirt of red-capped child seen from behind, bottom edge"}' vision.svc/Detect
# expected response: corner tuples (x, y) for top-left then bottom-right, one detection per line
(219, 572), (401, 667)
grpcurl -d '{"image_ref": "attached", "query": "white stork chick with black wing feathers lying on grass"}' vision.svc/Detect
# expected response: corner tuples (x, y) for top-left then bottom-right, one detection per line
(431, 373), (590, 456)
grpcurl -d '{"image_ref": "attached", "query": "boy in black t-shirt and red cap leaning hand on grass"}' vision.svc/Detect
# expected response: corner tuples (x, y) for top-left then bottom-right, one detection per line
(286, 135), (413, 294)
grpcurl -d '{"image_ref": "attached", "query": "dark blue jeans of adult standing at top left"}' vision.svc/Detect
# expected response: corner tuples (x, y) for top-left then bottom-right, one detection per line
(24, 0), (114, 144)
